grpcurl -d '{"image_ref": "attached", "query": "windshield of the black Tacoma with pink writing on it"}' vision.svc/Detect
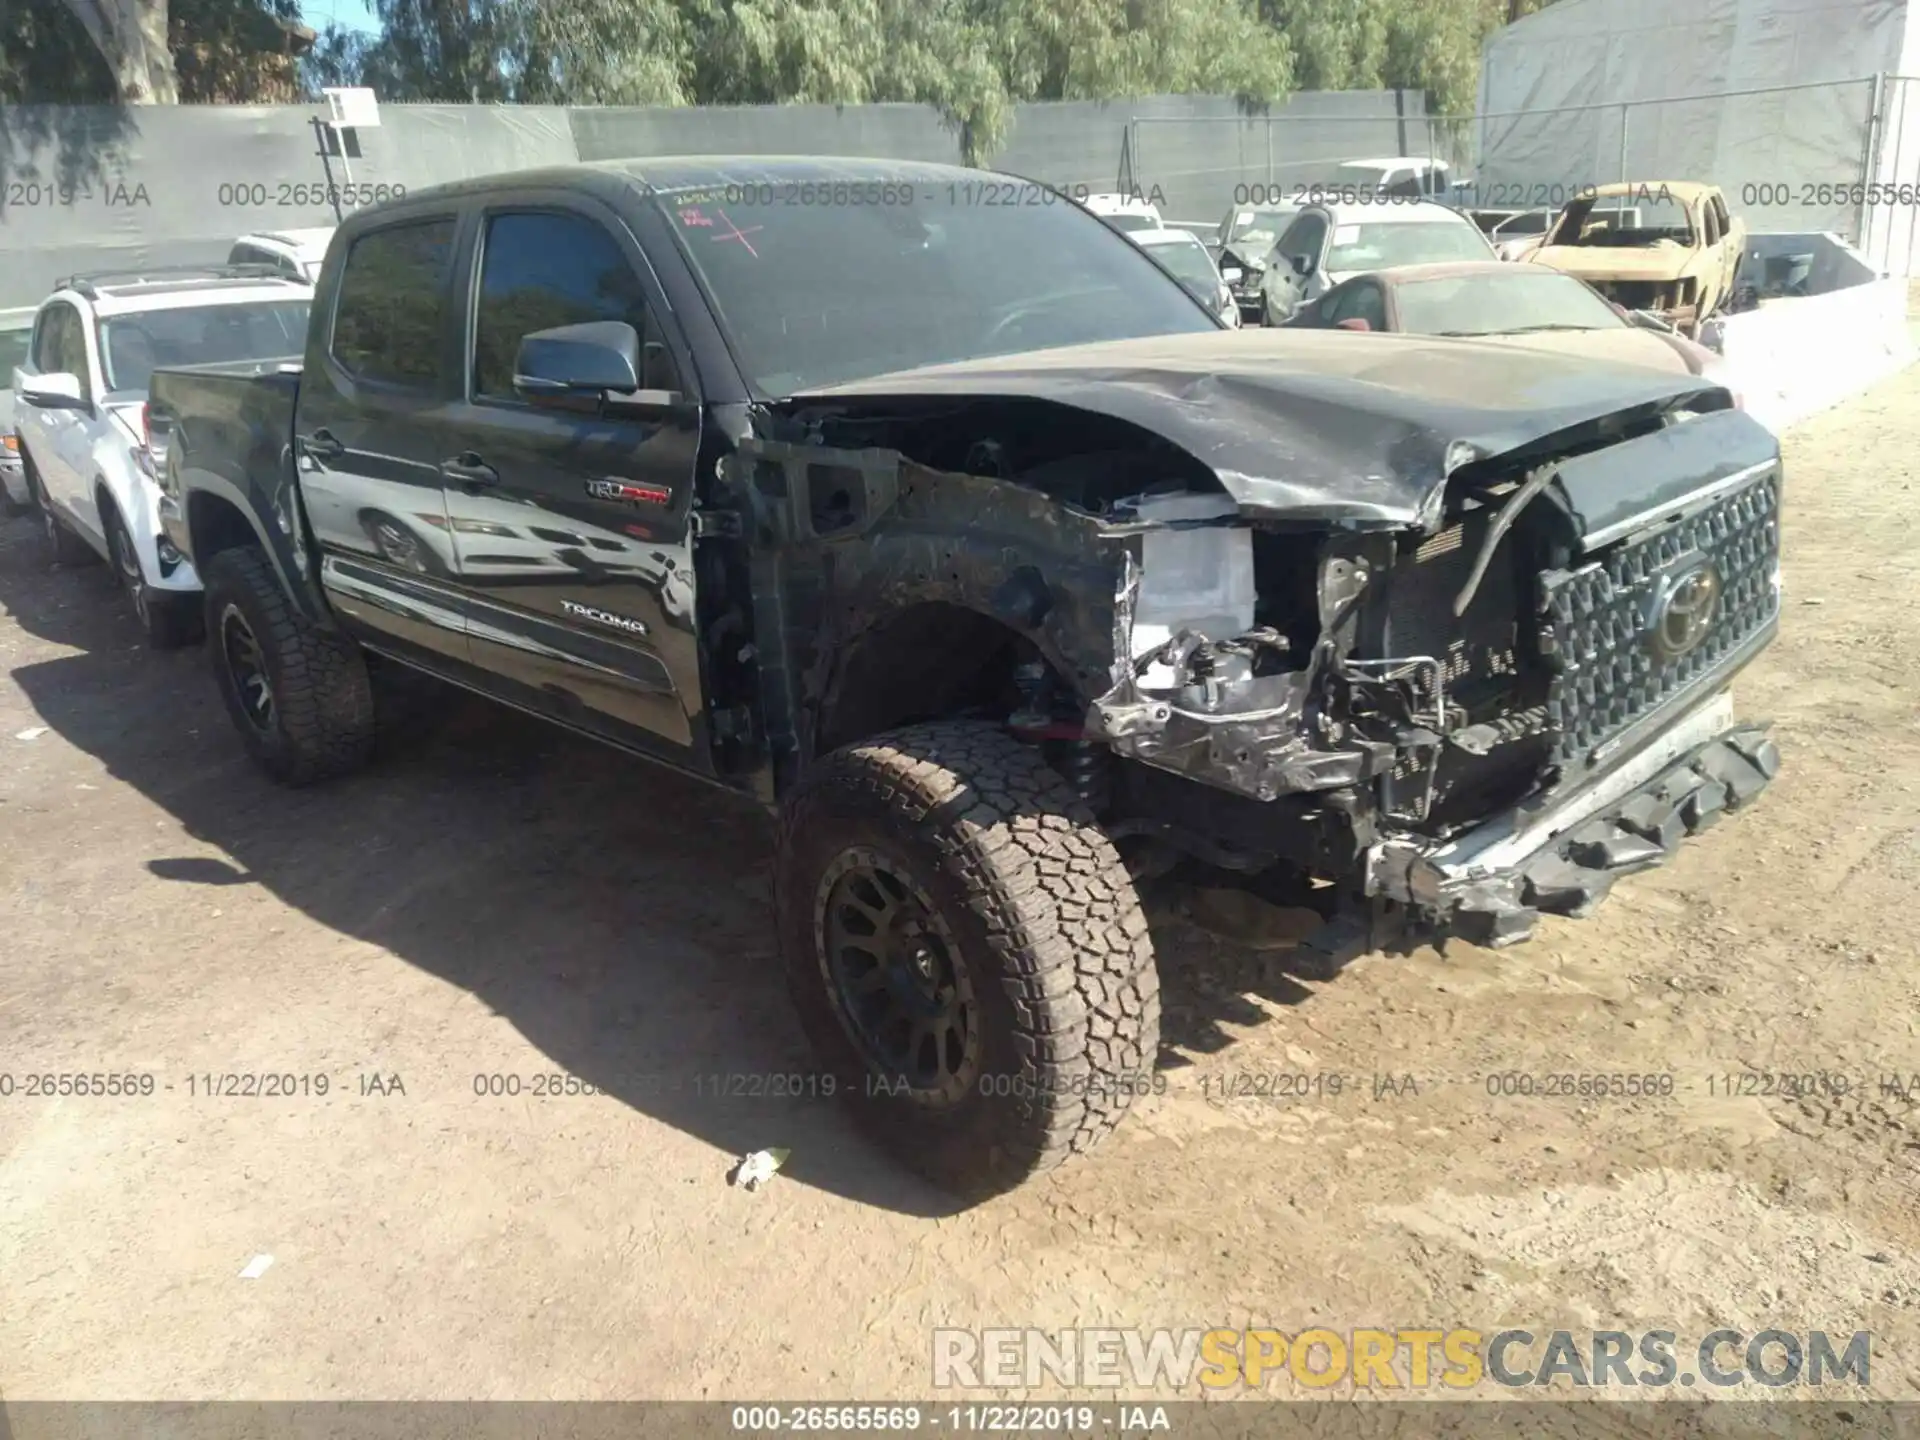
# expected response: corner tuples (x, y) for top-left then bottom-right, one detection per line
(662, 180), (1217, 396)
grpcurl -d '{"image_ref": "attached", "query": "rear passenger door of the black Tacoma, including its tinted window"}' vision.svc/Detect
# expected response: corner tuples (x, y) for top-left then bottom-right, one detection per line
(294, 213), (467, 666)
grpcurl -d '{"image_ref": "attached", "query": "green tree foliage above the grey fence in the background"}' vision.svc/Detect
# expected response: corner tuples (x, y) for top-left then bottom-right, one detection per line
(0, 0), (1553, 157)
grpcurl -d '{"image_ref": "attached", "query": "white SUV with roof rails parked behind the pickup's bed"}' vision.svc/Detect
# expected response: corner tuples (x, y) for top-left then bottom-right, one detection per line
(13, 267), (313, 645)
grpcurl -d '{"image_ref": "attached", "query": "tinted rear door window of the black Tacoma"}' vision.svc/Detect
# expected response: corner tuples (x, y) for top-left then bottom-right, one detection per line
(332, 219), (453, 390)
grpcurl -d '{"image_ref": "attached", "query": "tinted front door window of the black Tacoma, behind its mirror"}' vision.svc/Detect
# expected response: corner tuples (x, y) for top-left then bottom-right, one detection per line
(472, 211), (682, 403)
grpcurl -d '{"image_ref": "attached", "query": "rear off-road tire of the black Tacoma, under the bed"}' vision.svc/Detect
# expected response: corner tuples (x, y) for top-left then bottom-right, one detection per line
(202, 549), (374, 785)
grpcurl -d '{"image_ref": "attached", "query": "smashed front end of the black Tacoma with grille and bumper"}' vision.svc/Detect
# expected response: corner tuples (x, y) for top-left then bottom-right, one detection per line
(1087, 409), (1782, 945)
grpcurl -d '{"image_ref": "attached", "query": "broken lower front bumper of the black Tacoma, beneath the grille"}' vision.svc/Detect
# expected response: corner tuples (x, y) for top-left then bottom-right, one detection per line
(1367, 691), (1780, 947)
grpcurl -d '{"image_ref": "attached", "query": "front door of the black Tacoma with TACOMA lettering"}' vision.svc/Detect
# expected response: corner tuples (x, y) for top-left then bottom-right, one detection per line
(445, 204), (708, 770)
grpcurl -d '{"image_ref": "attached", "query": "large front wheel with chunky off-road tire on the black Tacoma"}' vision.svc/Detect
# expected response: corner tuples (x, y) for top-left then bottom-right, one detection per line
(774, 724), (1160, 1196)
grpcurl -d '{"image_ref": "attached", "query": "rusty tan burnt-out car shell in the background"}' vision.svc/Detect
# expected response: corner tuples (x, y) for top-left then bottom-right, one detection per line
(1526, 180), (1747, 340)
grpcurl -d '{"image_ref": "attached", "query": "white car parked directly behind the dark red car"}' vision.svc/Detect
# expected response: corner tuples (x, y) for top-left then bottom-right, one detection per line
(1260, 200), (1500, 324)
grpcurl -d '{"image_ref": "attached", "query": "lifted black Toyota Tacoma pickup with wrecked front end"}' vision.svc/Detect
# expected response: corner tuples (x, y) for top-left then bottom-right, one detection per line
(150, 159), (1780, 1194)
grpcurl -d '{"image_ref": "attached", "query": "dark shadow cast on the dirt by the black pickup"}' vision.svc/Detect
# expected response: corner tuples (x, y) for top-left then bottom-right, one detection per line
(0, 520), (1309, 1215)
